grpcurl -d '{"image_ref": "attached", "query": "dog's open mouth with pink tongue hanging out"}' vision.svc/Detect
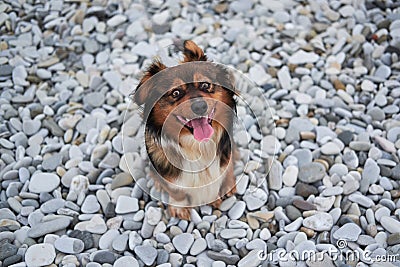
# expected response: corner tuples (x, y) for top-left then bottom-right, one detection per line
(176, 107), (215, 142)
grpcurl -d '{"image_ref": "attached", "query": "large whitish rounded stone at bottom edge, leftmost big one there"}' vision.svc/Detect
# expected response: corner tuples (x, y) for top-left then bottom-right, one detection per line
(25, 243), (56, 267)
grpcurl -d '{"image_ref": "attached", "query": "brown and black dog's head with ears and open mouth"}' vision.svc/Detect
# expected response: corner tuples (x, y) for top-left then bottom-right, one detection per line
(134, 41), (236, 141)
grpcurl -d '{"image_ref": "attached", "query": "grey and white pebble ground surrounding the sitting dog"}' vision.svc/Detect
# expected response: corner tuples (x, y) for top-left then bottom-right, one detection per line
(0, 0), (400, 267)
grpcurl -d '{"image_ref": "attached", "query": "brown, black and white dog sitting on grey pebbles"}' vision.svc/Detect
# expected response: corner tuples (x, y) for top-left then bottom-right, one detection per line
(133, 40), (236, 220)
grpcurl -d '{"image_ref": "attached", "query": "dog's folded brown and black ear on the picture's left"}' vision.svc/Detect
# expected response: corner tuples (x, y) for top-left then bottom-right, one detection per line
(134, 59), (166, 105)
